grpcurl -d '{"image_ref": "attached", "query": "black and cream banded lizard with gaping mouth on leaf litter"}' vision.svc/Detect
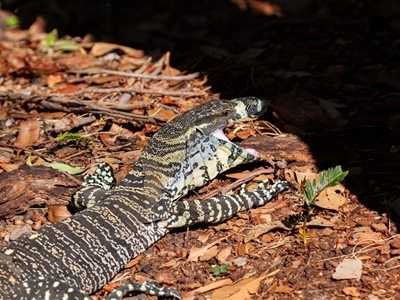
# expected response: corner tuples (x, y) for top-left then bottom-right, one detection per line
(0, 97), (289, 300)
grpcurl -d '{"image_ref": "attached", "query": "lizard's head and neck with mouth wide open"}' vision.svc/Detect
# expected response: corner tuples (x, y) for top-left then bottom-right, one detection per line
(140, 97), (268, 199)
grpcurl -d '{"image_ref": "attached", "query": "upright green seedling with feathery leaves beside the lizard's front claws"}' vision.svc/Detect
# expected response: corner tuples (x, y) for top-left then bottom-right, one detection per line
(302, 166), (349, 244)
